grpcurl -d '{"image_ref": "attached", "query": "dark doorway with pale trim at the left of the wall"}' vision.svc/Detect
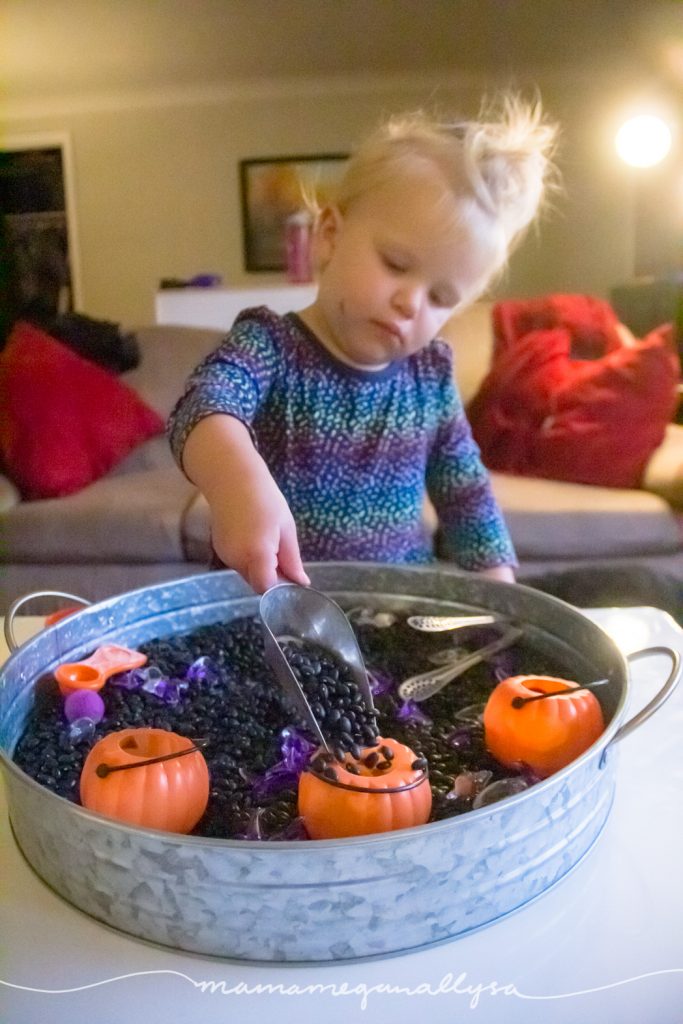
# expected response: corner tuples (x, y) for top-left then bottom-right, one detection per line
(0, 132), (82, 319)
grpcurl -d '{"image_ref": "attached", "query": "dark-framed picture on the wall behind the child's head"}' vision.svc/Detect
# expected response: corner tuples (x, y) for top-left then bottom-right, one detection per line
(240, 153), (348, 272)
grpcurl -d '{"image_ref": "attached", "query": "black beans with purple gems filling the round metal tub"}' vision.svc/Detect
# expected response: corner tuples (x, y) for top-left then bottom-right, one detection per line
(14, 607), (575, 841)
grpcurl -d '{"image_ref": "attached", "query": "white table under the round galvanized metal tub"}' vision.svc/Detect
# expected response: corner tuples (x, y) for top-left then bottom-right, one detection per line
(0, 608), (683, 1024)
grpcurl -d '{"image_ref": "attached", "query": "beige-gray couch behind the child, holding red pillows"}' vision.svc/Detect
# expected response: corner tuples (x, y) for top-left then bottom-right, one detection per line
(0, 303), (683, 610)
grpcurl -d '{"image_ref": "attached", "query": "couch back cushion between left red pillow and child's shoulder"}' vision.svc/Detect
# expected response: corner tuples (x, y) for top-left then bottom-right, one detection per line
(123, 326), (224, 419)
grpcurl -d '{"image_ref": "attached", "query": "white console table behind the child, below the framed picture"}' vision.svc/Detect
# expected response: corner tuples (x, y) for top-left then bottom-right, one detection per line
(155, 284), (317, 331)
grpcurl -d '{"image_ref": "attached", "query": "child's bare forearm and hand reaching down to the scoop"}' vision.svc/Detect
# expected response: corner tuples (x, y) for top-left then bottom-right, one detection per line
(182, 414), (310, 593)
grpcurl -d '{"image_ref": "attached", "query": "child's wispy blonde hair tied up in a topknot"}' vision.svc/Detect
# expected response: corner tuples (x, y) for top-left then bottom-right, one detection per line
(307, 94), (557, 294)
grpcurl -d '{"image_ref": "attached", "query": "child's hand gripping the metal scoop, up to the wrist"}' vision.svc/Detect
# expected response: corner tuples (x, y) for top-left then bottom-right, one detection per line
(211, 472), (310, 594)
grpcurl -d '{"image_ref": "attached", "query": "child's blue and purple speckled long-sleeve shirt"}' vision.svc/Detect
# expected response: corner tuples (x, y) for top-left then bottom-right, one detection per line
(169, 307), (516, 569)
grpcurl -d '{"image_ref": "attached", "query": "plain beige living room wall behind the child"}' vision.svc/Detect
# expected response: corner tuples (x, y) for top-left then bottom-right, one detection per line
(7, 76), (634, 326)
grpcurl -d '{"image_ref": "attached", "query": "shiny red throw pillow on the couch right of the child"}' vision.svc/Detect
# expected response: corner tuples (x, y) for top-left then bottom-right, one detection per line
(468, 299), (680, 487)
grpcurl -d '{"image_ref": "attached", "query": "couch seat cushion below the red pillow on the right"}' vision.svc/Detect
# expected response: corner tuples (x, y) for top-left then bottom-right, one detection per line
(492, 473), (681, 560)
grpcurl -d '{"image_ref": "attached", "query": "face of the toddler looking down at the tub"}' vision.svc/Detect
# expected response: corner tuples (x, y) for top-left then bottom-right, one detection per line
(315, 164), (495, 366)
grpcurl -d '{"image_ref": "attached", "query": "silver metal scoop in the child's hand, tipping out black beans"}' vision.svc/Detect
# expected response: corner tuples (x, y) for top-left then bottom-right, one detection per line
(259, 583), (375, 750)
